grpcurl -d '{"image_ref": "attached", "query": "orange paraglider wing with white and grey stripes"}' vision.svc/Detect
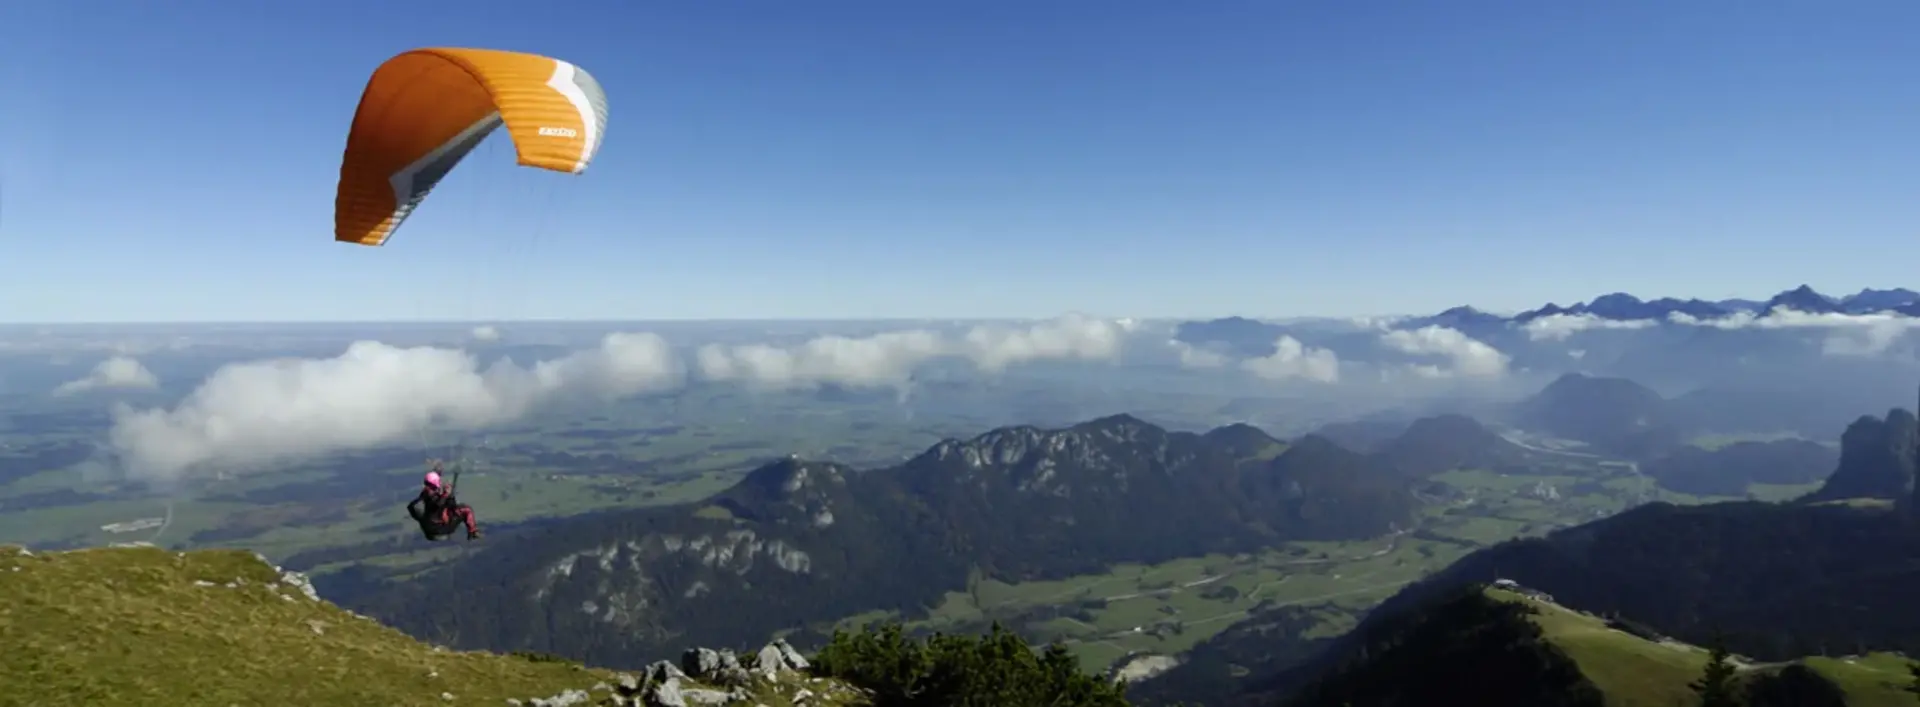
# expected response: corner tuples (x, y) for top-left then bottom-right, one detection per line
(334, 48), (607, 246)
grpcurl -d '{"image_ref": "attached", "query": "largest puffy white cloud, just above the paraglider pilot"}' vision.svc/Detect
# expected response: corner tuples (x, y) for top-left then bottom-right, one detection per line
(109, 334), (684, 478)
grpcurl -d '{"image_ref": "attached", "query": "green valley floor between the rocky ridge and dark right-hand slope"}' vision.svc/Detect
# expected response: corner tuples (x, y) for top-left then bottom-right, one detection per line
(837, 459), (1674, 670)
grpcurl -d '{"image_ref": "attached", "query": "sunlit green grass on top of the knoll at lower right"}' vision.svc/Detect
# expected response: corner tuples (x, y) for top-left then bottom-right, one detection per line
(1486, 590), (1914, 707)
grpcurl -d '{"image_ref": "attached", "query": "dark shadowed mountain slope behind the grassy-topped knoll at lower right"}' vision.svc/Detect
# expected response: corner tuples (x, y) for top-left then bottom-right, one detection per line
(1221, 501), (1920, 705)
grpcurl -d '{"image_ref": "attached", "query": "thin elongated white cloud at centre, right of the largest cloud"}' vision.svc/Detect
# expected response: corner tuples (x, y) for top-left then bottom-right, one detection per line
(695, 315), (1133, 388)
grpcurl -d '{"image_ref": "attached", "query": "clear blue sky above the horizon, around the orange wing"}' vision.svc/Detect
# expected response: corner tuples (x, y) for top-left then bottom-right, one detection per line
(0, 0), (1920, 321)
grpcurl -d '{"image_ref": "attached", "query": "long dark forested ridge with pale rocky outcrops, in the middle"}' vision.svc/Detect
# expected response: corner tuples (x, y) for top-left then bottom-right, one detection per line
(323, 415), (1505, 665)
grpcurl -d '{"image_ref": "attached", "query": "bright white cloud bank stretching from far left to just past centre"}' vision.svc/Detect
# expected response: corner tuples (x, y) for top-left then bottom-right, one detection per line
(109, 315), (1131, 480)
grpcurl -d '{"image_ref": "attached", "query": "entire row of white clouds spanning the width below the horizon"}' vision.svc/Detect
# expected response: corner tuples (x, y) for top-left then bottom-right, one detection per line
(105, 311), (1920, 478)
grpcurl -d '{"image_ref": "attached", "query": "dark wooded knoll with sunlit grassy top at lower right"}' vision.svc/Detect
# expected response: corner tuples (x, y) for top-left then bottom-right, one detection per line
(1274, 586), (1916, 707)
